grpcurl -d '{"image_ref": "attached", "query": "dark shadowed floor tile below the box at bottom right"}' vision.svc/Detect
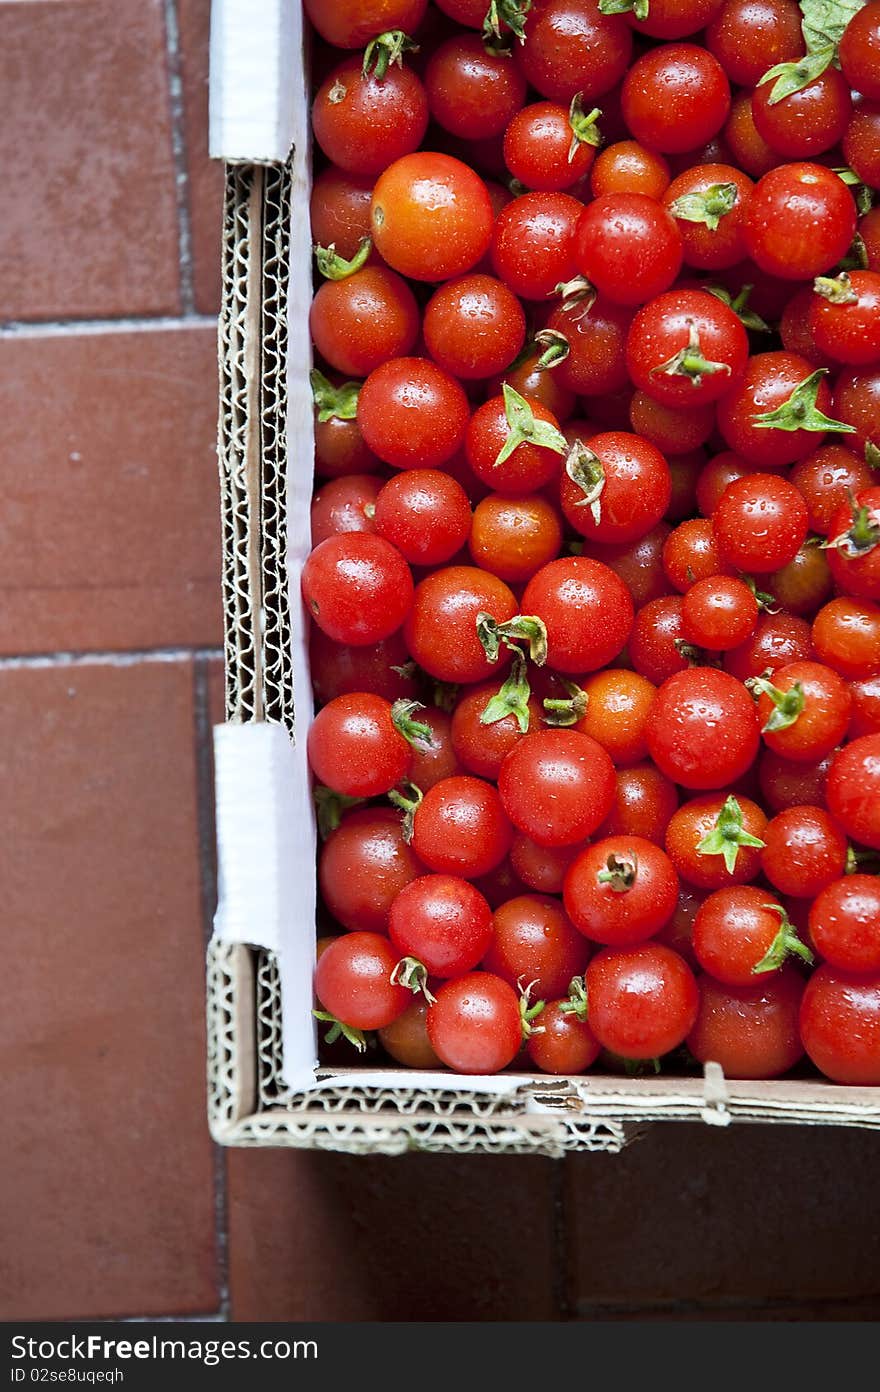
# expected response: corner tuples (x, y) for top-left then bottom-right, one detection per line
(567, 1122), (880, 1317)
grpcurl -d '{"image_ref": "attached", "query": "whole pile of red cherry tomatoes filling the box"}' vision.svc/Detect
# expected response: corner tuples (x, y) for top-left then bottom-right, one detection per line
(302, 0), (880, 1086)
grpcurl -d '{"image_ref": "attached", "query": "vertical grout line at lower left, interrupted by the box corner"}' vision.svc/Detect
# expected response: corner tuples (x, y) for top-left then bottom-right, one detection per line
(192, 654), (230, 1321)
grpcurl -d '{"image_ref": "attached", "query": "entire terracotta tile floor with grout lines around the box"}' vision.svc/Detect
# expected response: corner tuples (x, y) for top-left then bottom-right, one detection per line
(0, 0), (880, 1321)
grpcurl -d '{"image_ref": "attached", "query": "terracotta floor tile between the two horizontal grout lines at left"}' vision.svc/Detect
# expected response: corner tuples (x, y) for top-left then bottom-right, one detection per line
(0, 324), (221, 653)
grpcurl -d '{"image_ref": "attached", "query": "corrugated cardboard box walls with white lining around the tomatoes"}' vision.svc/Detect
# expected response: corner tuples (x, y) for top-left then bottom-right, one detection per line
(207, 0), (880, 1155)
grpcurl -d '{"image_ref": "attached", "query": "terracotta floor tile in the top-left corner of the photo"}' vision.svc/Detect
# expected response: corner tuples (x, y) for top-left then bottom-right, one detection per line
(0, 0), (180, 320)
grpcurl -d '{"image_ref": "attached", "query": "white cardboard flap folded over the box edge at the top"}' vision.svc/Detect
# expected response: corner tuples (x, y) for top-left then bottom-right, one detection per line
(207, 0), (302, 164)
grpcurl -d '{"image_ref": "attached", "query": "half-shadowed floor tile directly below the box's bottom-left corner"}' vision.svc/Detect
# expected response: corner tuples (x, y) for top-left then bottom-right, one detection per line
(227, 1150), (557, 1321)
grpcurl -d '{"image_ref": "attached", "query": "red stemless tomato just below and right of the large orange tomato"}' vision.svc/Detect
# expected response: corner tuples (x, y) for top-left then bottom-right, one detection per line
(423, 276), (525, 380)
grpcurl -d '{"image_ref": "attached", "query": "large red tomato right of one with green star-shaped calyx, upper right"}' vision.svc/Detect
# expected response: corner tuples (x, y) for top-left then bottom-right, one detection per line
(745, 160), (856, 280)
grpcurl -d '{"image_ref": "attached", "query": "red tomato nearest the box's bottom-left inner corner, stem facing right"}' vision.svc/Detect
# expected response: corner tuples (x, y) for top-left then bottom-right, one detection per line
(315, 933), (411, 1030)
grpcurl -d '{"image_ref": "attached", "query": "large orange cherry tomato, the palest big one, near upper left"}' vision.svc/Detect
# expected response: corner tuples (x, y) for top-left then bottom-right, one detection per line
(370, 150), (494, 281)
